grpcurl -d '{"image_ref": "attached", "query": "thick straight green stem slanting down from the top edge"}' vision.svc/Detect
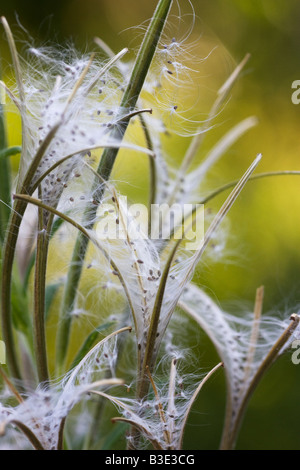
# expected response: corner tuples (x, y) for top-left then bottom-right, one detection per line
(57, 0), (172, 370)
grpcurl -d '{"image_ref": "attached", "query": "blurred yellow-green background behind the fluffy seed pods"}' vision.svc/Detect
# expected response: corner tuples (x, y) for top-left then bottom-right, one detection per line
(0, 0), (300, 449)
